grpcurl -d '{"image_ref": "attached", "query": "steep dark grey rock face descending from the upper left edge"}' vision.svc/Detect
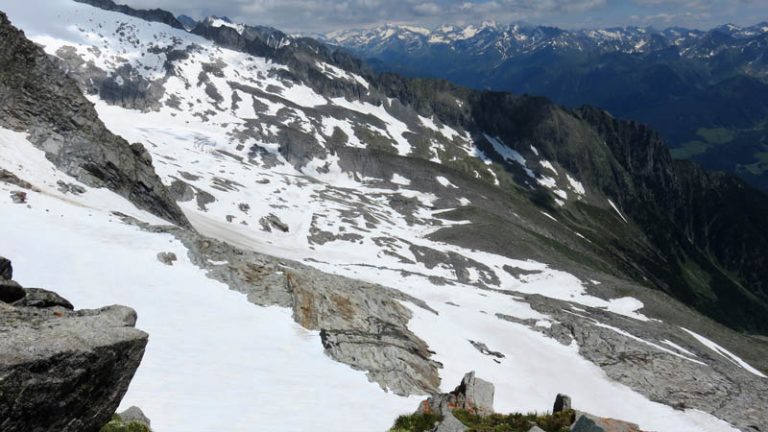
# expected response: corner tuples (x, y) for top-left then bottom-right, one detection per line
(0, 13), (188, 226)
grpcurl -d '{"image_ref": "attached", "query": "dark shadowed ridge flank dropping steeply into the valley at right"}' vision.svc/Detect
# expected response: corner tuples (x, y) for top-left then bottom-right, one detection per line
(375, 74), (768, 334)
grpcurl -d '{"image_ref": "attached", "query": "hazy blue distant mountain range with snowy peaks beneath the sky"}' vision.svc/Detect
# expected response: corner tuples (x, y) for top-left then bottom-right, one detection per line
(324, 22), (768, 190)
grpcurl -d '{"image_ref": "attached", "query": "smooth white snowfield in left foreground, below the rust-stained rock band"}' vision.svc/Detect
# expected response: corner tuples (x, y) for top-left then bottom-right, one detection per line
(0, 129), (417, 432)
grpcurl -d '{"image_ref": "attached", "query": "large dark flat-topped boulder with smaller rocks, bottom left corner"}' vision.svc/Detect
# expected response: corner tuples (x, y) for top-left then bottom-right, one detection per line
(0, 258), (147, 432)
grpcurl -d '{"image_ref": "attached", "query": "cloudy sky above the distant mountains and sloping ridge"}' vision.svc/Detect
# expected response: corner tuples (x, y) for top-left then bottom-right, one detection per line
(123, 0), (768, 33)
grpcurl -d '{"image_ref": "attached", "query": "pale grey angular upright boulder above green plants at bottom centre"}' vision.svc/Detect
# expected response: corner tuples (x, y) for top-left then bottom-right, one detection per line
(417, 372), (494, 416)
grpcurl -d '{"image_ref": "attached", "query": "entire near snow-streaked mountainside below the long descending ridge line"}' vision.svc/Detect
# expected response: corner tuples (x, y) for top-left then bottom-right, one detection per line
(0, 0), (768, 432)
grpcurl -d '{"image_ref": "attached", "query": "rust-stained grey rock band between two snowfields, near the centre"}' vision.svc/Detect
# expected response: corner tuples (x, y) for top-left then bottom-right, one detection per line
(116, 213), (442, 396)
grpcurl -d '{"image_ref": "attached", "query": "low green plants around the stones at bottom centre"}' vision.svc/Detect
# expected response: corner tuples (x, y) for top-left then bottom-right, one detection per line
(390, 410), (575, 432)
